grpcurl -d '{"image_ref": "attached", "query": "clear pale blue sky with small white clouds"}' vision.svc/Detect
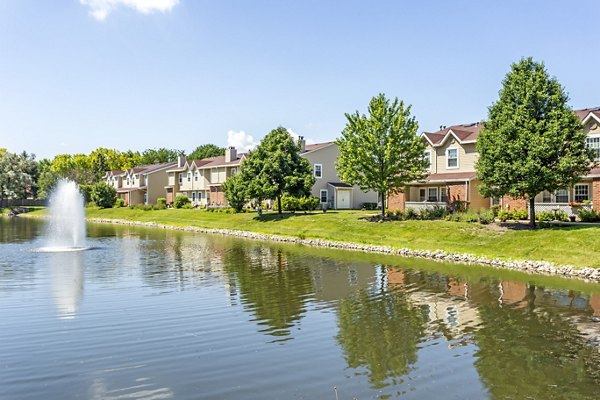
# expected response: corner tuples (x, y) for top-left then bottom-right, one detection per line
(0, 0), (600, 159)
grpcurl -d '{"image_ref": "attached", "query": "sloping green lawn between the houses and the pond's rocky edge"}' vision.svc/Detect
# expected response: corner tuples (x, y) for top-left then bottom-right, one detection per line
(33, 208), (600, 267)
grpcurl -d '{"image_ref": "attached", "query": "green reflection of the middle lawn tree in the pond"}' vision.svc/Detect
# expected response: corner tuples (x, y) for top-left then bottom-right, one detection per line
(337, 268), (426, 387)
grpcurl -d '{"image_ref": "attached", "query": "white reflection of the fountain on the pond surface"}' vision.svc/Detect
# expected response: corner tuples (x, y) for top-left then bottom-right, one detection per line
(46, 251), (84, 319)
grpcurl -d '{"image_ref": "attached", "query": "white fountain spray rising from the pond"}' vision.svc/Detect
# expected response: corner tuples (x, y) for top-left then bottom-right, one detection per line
(39, 179), (87, 252)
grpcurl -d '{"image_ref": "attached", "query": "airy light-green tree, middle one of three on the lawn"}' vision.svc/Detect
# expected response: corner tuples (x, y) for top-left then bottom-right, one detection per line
(336, 93), (427, 218)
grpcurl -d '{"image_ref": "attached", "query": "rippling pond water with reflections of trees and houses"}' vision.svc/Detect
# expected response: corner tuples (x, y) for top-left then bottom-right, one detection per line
(0, 218), (600, 400)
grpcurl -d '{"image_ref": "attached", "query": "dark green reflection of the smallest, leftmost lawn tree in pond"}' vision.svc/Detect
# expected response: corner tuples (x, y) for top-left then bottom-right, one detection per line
(223, 243), (314, 336)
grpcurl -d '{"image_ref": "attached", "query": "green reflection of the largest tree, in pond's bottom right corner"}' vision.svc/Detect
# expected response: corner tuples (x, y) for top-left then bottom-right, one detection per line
(475, 286), (600, 399)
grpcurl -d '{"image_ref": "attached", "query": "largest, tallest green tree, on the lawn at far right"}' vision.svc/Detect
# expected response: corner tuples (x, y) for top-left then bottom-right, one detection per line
(476, 58), (593, 227)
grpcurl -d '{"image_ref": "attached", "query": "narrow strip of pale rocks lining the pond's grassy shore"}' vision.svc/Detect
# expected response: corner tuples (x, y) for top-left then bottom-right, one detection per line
(87, 218), (600, 282)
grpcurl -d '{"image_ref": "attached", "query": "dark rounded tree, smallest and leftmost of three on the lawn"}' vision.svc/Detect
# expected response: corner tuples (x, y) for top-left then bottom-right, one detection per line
(241, 127), (315, 214)
